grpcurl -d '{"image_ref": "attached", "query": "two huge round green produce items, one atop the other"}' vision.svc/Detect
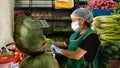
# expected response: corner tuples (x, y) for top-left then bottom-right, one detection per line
(15, 15), (59, 68)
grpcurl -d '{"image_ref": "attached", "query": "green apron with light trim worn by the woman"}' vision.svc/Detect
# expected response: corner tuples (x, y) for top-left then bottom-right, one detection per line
(65, 29), (99, 68)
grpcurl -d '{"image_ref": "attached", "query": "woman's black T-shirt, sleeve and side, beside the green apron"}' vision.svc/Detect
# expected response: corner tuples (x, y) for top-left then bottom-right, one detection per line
(80, 33), (100, 62)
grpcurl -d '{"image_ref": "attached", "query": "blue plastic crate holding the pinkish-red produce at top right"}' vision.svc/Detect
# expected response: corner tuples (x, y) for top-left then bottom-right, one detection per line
(91, 9), (113, 17)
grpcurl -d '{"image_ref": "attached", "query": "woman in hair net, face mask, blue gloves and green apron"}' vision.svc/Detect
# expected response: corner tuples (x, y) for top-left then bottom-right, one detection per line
(51, 8), (100, 68)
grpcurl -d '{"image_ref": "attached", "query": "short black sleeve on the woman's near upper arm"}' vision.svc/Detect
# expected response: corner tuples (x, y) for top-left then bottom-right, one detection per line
(79, 33), (100, 51)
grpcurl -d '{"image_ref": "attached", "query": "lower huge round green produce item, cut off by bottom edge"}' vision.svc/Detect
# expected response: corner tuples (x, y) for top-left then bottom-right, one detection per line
(20, 53), (59, 68)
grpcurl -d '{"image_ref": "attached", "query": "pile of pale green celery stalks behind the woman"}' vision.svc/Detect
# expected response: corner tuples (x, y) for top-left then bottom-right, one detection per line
(93, 14), (120, 46)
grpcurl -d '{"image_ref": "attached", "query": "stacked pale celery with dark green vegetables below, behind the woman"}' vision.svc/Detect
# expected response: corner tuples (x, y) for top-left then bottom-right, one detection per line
(93, 14), (120, 59)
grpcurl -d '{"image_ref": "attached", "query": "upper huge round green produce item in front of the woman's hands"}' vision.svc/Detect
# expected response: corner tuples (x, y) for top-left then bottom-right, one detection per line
(15, 15), (51, 55)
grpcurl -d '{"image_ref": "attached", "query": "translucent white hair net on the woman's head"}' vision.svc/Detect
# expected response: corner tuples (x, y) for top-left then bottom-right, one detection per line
(71, 8), (93, 23)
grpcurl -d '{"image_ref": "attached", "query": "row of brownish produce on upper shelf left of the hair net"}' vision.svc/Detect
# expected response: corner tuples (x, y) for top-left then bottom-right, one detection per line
(31, 10), (70, 19)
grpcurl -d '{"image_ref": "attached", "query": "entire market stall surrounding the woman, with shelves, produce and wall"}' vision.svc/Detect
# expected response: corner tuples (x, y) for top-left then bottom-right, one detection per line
(0, 0), (120, 68)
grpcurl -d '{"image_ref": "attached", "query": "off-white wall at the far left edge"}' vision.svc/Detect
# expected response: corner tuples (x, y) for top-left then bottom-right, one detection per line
(0, 0), (14, 48)
